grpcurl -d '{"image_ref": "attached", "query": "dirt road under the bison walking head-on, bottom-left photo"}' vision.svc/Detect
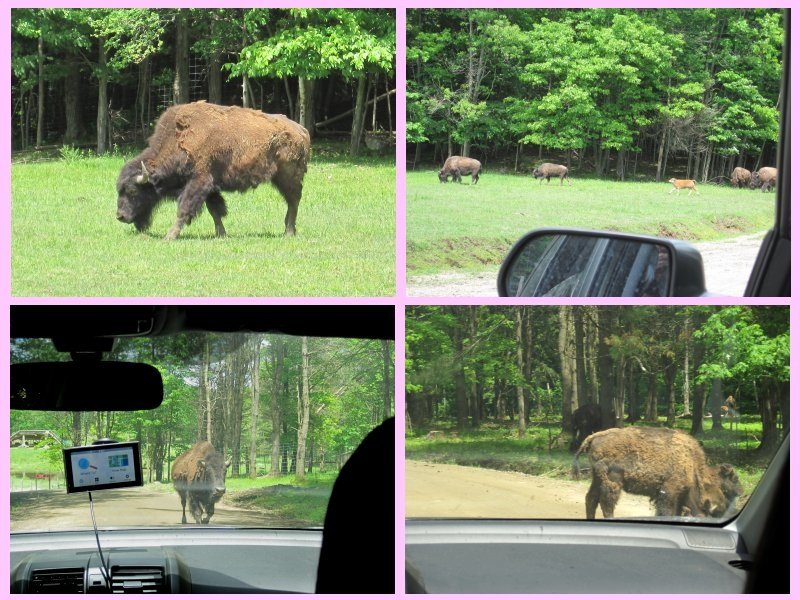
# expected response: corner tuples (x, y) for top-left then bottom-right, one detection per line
(11, 486), (272, 531)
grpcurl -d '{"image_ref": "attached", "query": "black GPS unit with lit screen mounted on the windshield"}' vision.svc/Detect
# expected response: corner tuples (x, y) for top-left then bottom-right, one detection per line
(64, 442), (142, 494)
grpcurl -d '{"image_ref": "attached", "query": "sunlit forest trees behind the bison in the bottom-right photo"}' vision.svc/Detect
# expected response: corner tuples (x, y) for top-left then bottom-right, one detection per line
(406, 306), (789, 451)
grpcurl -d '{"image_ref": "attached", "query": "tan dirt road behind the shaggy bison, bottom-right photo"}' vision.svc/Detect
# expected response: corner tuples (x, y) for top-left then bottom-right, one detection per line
(405, 460), (655, 519)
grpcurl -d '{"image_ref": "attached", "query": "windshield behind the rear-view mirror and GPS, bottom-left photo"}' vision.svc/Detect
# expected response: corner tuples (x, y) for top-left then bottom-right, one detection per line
(10, 333), (394, 532)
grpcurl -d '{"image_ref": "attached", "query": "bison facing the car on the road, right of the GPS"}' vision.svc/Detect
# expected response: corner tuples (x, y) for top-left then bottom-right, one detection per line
(172, 442), (231, 523)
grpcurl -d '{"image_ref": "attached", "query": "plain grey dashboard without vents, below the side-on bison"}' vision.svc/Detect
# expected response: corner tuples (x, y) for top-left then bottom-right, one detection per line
(406, 520), (750, 594)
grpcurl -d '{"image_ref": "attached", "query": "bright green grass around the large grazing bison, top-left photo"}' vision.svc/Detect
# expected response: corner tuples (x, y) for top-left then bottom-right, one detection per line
(11, 147), (395, 297)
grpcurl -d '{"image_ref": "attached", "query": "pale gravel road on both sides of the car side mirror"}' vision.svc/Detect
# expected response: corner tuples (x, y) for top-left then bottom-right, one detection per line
(406, 232), (766, 297)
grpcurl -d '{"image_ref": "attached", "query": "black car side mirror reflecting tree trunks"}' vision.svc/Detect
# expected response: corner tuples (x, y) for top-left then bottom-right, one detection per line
(497, 229), (706, 297)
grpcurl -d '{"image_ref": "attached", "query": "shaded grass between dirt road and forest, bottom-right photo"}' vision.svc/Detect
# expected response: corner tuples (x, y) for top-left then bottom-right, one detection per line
(405, 415), (768, 497)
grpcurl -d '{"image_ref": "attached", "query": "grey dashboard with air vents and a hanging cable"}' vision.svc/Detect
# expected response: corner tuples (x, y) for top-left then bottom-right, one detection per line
(11, 527), (322, 594)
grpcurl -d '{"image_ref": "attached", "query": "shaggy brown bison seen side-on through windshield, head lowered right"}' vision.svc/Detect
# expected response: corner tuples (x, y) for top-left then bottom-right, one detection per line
(572, 427), (742, 519)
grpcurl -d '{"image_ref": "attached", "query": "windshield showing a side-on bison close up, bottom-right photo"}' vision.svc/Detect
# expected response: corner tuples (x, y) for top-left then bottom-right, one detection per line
(406, 306), (789, 522)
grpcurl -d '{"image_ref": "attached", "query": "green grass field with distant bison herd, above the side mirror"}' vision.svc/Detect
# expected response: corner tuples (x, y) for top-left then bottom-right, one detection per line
(406, 171), (775, 274)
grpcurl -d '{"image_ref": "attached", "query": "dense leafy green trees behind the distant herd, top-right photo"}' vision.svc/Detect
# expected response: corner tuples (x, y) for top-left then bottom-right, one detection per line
(407, 8), (783, 180)
